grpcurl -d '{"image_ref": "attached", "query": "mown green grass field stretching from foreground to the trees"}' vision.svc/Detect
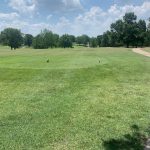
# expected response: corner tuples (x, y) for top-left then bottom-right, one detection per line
(0, 47), (150, 150)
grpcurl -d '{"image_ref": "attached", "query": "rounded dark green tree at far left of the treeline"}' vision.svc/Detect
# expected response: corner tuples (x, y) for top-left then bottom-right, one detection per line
(0, 28), (23, 50)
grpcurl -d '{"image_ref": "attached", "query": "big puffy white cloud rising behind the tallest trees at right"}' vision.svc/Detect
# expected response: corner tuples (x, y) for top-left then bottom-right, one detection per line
(67, 2), (150, 36)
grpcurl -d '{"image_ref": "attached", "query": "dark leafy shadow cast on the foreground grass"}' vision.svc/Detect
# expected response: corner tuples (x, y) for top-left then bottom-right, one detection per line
(103, 125), (150, 150)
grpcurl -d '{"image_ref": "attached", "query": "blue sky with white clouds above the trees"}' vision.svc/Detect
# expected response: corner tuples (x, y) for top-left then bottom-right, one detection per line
(0, 0), (150, 36)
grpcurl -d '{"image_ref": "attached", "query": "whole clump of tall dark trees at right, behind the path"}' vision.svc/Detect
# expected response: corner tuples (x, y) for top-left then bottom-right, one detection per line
(97, 12), (150, 47)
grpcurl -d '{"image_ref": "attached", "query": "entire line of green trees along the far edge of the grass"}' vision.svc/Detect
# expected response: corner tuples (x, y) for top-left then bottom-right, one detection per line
(0, 12), (150, 49)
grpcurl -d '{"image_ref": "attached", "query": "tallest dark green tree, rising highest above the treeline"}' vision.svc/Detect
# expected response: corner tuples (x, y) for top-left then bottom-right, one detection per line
(110, 12), (141, 47)
